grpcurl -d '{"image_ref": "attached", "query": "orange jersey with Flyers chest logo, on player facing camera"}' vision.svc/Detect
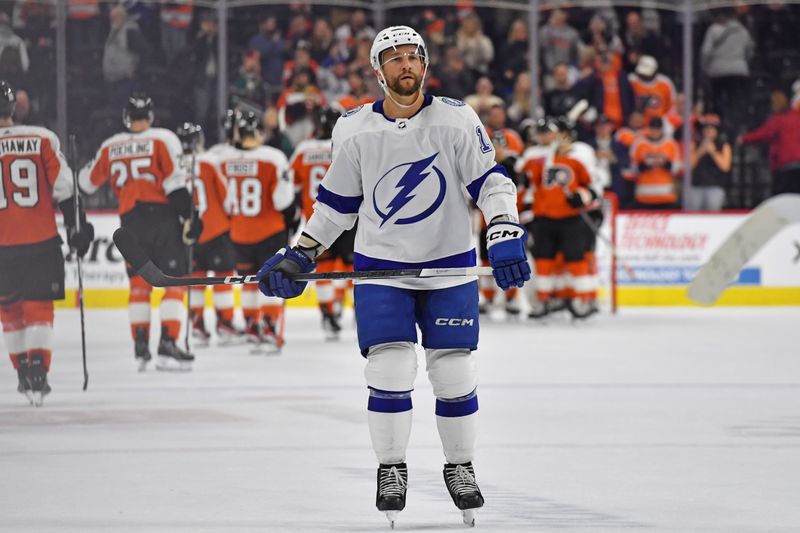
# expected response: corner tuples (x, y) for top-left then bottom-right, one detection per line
(523, 155), (592, 218)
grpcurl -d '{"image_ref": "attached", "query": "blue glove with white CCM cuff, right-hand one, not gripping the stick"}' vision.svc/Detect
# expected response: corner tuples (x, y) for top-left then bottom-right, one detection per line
(486, 222), (531, 290)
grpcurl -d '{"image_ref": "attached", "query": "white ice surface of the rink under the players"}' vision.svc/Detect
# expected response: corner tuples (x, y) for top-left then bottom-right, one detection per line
(0, 308), (800, 533)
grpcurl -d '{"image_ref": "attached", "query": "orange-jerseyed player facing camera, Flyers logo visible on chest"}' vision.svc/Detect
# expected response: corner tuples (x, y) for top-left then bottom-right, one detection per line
(521, 120), (596, 318)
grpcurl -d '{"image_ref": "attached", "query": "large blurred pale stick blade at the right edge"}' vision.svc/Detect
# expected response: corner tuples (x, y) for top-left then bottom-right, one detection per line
(686, 194), (800, 305)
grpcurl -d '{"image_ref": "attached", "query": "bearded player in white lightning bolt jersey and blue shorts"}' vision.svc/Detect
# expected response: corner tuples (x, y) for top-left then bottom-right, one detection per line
(258, 26), (530, 525)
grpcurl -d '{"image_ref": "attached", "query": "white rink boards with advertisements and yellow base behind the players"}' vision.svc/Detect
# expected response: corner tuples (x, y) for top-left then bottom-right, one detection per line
(58, 212), (800, 308)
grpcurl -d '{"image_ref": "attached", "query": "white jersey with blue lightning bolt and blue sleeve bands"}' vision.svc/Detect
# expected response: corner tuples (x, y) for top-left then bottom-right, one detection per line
(305, 95), (517, 289)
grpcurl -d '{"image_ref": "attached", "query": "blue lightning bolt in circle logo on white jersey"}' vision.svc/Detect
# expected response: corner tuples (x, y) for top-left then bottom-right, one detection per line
(372, 152), (447, 227)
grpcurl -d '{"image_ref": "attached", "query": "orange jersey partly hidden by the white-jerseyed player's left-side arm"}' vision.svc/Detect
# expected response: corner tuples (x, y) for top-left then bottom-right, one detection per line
(289, 139), (333, 220)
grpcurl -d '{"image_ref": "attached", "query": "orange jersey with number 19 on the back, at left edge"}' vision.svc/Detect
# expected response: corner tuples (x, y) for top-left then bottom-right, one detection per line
(0, 126), (73, 246)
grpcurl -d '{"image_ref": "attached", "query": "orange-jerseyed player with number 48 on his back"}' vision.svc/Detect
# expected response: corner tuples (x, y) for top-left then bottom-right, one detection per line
(217, 111), (295, 351)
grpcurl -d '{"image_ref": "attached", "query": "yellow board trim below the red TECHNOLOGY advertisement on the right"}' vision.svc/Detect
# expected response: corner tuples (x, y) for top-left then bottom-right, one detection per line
(617, 286), (800, 307)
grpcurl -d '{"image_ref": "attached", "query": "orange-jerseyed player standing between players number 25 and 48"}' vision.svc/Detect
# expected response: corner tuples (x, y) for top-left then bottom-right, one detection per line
(176, 122), (241, 346)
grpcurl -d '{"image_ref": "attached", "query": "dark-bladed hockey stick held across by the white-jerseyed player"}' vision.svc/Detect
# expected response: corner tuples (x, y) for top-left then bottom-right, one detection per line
(114, 228), (492, 287)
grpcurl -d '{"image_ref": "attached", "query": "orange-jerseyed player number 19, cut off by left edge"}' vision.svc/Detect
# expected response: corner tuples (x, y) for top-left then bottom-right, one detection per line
(0, 81), (94, 407)
